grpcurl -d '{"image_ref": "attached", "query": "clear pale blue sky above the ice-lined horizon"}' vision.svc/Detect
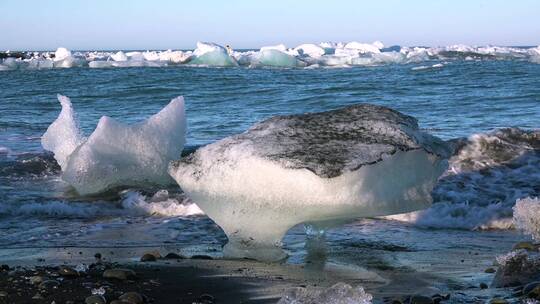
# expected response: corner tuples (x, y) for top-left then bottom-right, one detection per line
(0, 0), (540, 50)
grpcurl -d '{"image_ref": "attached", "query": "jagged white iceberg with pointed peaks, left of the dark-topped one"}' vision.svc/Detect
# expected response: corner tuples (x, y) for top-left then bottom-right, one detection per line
(41, 95), (186, 195)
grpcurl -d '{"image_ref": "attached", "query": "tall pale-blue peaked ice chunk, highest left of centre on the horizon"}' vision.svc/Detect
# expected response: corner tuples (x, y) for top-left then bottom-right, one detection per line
(189, 42), (238, 67)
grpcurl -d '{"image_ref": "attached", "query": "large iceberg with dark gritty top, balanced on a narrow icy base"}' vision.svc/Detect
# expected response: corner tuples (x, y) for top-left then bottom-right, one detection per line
(169, 104), (450, 260)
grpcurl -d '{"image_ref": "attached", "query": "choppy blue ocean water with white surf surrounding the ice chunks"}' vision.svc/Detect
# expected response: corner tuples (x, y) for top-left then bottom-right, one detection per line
(0, 44), (540, 296)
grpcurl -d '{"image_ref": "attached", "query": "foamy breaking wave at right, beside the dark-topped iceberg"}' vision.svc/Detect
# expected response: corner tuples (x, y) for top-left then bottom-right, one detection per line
(385, 128), (540, 229)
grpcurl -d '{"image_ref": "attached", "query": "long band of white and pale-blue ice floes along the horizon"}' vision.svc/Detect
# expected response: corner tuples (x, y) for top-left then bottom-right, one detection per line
(4, 41), (540, 71)
